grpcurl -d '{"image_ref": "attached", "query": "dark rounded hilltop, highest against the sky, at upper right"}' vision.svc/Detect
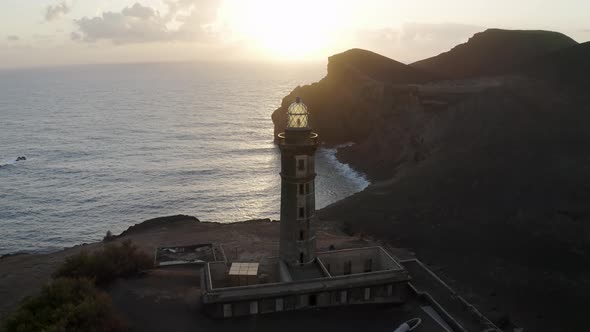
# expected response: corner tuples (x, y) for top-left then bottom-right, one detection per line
(411, 29), (577, 79)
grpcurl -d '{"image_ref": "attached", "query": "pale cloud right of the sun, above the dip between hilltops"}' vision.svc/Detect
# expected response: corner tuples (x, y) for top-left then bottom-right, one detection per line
(356, 22), (485, 62)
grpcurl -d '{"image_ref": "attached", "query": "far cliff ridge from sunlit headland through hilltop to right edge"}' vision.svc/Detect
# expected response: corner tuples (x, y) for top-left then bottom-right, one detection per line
(272, 29), (590, 180)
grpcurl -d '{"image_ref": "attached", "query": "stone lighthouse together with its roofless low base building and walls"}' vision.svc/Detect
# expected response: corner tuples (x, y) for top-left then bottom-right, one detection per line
(201, 98), (499, 332)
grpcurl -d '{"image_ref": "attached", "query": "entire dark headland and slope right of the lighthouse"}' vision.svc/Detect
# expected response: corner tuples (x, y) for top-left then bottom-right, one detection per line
(273, 30), (590, 331)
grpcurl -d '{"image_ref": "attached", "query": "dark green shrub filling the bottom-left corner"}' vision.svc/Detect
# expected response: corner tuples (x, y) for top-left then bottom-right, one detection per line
(2, 278), (127, 332)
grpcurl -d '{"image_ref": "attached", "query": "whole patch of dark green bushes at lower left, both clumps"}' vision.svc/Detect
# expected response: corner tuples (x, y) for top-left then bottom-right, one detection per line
(0, 240), (153, 332)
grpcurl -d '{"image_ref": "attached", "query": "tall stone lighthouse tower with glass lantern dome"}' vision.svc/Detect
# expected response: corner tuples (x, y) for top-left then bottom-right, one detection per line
(278, 97), (318, 267)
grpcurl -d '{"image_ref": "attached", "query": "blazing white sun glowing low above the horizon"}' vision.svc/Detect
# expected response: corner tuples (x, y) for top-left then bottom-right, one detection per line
(225, 0), (341, 61)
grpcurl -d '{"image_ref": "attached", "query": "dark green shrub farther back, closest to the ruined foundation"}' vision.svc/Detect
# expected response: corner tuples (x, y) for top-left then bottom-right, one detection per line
(54, 240), (153, 284)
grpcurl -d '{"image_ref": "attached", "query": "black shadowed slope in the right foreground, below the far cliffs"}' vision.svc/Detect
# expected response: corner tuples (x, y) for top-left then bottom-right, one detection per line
(319, 81), (590, 331)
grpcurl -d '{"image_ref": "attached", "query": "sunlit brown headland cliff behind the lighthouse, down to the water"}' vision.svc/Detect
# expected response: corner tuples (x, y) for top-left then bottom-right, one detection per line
(272, 49), (436, 179)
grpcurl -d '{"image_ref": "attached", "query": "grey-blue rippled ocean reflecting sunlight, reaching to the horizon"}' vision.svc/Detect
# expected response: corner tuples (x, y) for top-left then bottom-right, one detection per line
(0, 63), (368, 255)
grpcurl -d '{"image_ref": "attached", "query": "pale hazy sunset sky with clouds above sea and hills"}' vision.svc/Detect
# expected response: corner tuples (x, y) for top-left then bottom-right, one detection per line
(0, 0), (590, 68)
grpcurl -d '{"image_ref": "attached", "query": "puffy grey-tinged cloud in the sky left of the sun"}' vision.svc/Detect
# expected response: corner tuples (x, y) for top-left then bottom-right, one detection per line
(70, 0), (219, 44)
